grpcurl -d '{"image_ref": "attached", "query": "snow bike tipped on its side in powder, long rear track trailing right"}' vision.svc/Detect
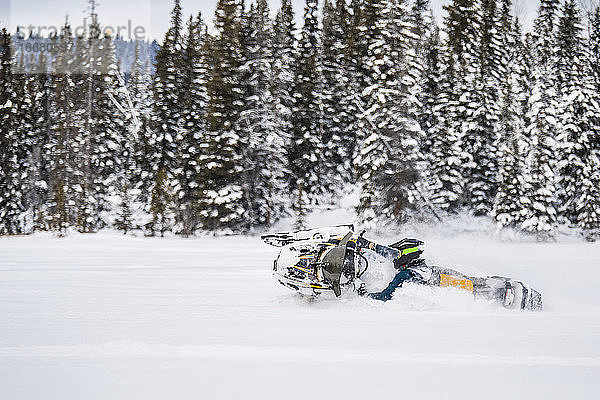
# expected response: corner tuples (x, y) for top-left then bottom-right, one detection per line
(261, 225), (542, 311)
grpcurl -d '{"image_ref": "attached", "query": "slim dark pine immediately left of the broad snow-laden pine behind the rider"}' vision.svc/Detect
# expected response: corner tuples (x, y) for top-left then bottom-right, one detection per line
(322, 0), (359, 188)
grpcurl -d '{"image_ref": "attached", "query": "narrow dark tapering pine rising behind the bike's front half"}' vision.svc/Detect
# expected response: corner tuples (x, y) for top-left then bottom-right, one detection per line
(287, 0), (324, 222)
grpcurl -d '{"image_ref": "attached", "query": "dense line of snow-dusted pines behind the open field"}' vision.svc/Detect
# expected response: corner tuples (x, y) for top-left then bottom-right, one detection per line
(0, 0), (600, 240)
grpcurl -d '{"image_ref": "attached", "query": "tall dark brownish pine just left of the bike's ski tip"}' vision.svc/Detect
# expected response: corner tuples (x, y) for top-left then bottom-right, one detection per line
(199, 0), (245, 230)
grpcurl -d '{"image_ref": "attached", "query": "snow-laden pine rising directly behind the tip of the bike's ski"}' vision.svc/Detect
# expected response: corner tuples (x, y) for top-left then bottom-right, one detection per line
(237, 0), (286, 229)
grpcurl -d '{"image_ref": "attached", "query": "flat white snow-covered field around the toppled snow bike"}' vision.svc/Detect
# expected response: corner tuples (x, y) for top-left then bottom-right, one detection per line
(0, 225), (600, 400)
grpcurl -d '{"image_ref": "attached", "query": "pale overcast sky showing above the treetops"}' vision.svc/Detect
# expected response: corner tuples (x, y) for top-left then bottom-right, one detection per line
(0, 0), (538, 41)
